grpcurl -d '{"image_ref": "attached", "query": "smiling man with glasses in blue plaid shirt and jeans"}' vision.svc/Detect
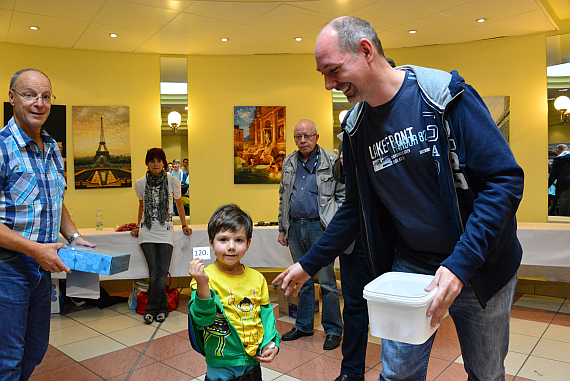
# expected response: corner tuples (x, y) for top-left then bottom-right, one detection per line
(0, 69), (95, 380)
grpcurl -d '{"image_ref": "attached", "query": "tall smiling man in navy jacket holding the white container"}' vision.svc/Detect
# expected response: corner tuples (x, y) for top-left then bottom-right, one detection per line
(274, 17), (523, 381)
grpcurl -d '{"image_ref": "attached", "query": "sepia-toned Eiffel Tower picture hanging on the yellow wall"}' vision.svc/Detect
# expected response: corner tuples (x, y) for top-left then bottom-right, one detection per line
(72, 106), (132, 189)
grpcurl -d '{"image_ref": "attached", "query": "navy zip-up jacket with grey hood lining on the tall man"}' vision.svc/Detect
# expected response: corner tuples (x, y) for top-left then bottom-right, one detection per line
(299, 66), (524, 308)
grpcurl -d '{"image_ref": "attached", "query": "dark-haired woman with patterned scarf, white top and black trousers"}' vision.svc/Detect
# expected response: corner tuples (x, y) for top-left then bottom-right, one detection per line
(131, 148), (192, 324)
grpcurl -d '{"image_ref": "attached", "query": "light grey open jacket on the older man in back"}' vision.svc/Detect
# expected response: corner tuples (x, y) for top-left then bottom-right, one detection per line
(279, 146), (344, 238)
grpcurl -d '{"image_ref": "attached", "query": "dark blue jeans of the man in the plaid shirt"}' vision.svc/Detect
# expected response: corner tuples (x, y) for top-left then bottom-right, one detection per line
(0, 249), (51, 381)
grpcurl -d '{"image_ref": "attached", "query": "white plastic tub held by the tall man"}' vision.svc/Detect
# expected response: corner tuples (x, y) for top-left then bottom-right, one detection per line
(364, 272), (439, 344)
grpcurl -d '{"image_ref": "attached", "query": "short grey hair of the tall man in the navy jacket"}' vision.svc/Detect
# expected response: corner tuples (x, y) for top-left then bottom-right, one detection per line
(327, 16), (384, 57)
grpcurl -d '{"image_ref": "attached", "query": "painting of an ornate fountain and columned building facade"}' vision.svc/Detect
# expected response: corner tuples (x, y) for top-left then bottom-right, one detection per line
(234, 106), (286, 184)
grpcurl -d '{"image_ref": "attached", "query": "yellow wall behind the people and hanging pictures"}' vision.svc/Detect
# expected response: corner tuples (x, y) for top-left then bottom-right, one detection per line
(0, 31), (548, 228)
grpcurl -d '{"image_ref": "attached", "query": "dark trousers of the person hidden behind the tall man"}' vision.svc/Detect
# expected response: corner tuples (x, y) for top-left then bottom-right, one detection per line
(340, 237), (374, 378)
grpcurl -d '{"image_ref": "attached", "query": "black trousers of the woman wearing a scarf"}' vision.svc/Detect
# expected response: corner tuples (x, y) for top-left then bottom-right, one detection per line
(141, 242), (173, 317)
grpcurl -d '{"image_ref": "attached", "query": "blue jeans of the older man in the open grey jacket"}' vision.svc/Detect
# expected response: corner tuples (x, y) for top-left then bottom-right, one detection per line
(288, 221), (343, 335)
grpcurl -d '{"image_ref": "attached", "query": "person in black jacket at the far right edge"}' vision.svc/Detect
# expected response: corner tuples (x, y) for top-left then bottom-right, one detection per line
(548, 144), (570, 216)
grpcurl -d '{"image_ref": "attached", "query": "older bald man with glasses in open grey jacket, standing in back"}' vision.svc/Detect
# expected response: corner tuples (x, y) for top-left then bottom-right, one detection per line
(278, 119), (344, 350)
